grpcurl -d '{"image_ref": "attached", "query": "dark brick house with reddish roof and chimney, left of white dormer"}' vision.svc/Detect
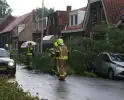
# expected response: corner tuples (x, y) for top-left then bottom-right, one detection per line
(46, 6), (71, 36)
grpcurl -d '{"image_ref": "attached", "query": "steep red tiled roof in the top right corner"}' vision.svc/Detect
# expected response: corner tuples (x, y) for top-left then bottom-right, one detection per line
(103, 0), (124, 24)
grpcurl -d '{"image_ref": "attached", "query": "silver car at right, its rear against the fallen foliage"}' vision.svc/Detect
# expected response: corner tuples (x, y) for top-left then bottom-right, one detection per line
(91, 52), (124, 79)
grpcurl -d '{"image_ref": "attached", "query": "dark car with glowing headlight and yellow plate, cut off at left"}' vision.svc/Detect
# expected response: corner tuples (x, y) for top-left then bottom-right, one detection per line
(0, 48), (16, 76)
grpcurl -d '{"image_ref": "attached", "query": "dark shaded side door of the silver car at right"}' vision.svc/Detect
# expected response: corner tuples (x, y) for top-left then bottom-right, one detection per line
(101, 54), (111, 75)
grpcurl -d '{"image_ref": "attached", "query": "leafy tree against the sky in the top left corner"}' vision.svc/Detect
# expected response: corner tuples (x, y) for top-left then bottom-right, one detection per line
(0, 0), (12, 17)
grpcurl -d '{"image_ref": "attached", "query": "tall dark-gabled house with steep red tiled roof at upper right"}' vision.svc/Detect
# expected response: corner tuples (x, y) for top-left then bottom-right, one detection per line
(83, 0), (124, 39)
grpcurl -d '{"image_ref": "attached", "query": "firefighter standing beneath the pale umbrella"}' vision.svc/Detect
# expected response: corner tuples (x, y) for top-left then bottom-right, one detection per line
(27, 42), (33, 66)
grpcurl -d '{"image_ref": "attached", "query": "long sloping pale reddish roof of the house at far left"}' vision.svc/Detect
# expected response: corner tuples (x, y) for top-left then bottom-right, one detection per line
(0, 12), (31, 33)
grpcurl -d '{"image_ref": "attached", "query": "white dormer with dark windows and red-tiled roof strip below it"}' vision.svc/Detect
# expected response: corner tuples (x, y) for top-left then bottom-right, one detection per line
(62, 7), (86, 34)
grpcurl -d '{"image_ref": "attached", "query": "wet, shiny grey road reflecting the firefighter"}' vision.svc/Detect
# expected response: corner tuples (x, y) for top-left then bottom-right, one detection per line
(16, 67), (124, 100)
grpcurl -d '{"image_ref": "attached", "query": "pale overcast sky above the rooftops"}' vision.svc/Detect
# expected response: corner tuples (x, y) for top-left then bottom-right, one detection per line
(7, 0), (87, 15)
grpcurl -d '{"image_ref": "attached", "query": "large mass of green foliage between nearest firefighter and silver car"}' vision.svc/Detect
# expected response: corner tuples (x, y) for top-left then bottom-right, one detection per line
(70, 24), (124, 74)
